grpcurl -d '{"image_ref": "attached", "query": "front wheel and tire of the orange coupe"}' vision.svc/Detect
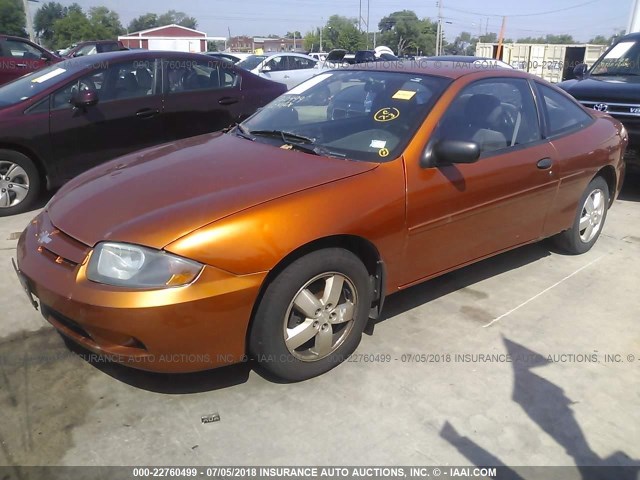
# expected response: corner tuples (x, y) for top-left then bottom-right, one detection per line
(249, 248), (372, 381)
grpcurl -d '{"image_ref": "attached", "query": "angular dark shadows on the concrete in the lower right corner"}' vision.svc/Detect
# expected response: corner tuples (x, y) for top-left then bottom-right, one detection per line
(440, 337), (640, 480)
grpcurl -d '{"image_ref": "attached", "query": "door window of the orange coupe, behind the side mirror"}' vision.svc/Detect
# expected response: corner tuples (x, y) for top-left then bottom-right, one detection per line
(435, 78), (541, 153)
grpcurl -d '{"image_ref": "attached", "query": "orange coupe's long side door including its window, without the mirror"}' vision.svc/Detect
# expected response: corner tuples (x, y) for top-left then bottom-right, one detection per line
(403, 78), (559, 285)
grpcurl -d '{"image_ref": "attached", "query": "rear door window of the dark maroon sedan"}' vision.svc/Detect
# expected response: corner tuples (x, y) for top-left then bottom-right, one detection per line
(165, 60), (238, 93)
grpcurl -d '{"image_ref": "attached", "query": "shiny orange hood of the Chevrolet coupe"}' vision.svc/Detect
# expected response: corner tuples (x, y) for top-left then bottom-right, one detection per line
(47, 134), (377, 248)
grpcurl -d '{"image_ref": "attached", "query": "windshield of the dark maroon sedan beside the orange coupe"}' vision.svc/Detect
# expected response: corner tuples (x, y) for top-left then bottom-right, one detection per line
(0, 61), (77, 108)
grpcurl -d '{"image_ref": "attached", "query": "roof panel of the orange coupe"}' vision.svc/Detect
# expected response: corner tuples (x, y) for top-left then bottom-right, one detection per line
(345, 59), (541, 80)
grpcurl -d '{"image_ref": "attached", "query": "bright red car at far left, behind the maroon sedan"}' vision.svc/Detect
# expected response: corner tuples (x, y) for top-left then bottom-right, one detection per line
(0, 35), (62, 85)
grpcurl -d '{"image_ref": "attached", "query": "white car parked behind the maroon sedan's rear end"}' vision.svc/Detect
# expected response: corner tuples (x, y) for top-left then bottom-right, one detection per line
(237, 52), (318, 90)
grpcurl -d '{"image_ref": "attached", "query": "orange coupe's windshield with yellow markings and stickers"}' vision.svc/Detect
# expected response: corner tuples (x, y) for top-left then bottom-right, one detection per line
(239, 70), (451, 162)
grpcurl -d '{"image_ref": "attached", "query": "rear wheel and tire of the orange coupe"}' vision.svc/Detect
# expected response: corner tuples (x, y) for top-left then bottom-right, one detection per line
(553, 177), (610, 255)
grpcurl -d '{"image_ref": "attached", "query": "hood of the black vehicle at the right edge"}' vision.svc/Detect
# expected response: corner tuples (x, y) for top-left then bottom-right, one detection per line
(558, 76), (640, 104)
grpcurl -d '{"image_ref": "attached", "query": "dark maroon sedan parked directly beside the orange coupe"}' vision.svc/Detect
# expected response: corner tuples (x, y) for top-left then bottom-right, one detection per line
(0, 50), (286, 216)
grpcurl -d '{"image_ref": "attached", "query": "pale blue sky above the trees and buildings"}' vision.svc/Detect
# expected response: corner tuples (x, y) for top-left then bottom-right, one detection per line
(30, 0), (633, 42)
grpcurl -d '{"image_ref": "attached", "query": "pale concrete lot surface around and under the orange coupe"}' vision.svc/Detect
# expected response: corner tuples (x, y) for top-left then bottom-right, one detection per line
(0, 176), (640, 472)
